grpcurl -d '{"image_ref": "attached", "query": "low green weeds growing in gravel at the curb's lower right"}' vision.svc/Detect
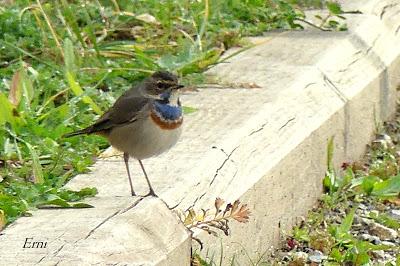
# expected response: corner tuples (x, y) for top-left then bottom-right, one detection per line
(282, 137), (400, 265)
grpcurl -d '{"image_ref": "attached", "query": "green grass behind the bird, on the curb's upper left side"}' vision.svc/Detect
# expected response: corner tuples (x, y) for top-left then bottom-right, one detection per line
(0, 0), (344, 229)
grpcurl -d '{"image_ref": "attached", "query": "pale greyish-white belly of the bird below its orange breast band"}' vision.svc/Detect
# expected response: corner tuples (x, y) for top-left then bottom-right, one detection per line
(108, 118), (182, 160)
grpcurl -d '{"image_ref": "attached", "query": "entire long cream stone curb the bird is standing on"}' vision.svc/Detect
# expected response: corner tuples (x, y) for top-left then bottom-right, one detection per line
(0, 0), (400, 265)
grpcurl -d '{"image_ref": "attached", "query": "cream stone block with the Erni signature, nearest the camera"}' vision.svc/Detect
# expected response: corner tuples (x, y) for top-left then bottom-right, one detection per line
(0, 197), (191, 265)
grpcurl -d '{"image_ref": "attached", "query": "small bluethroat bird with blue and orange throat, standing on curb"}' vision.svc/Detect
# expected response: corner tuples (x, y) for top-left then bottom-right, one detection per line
(65, 71), (183, 196)
